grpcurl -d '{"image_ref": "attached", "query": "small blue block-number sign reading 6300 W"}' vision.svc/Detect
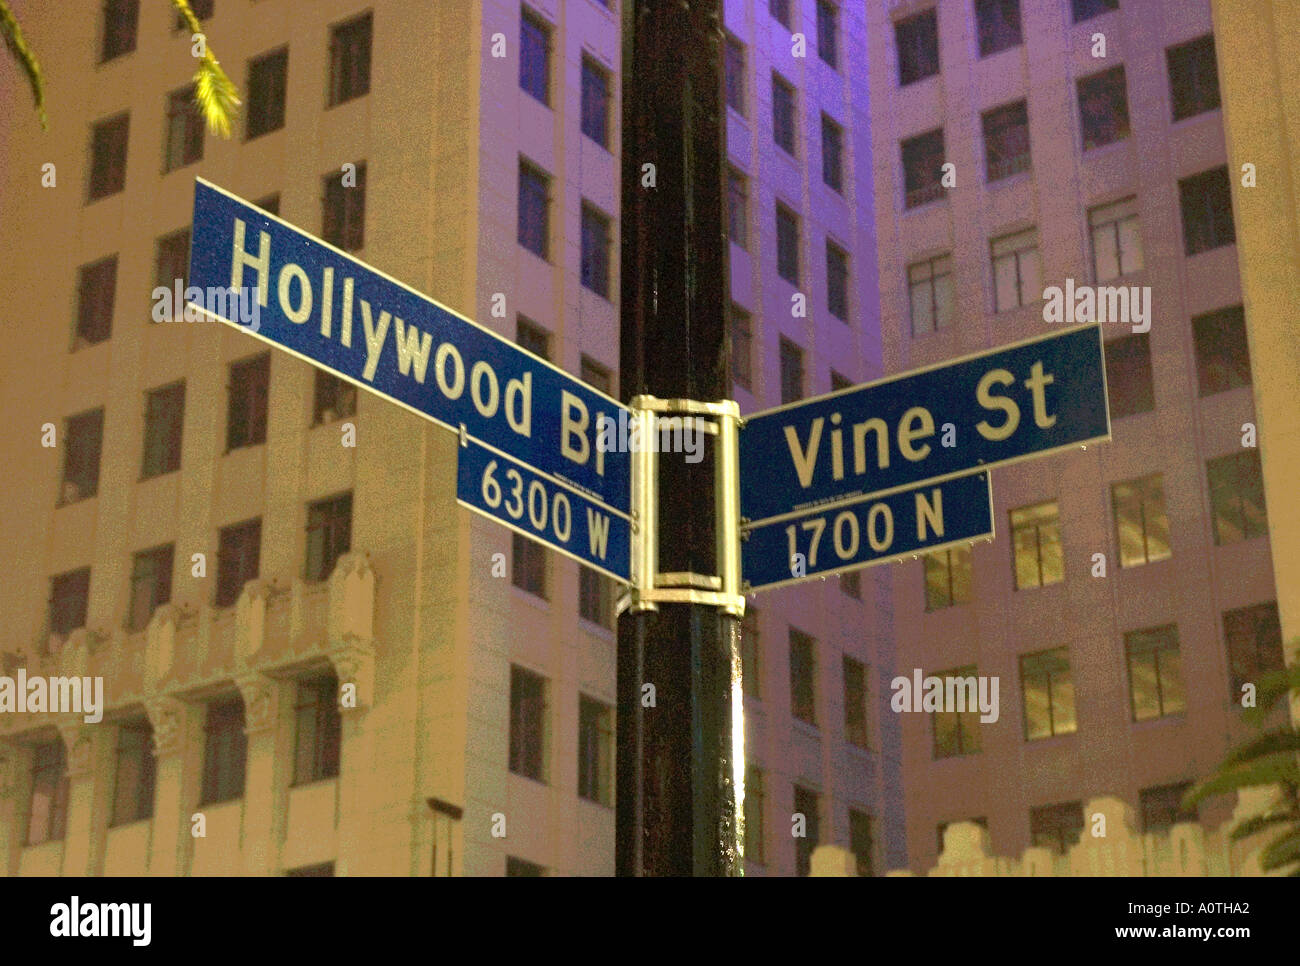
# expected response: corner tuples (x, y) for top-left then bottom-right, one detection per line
(456, 439), (632, 582)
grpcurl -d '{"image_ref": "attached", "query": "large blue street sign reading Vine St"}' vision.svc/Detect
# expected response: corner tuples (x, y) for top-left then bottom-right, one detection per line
(740, 324), (1110, 523)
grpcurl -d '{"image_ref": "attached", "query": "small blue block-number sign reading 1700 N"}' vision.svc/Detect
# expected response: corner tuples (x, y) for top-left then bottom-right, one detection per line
(741, 472), (993, 590)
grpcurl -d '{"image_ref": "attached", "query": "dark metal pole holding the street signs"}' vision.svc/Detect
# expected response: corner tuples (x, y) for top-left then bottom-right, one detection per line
(615, 0), (741, 875)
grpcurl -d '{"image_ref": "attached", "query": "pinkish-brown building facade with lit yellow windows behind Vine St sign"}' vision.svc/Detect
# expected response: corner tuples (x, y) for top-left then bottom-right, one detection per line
(867, 0), (1284, 871)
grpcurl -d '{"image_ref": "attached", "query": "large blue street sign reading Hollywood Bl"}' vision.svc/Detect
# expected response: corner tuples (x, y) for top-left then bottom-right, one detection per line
(185, 179), (632, 517)
